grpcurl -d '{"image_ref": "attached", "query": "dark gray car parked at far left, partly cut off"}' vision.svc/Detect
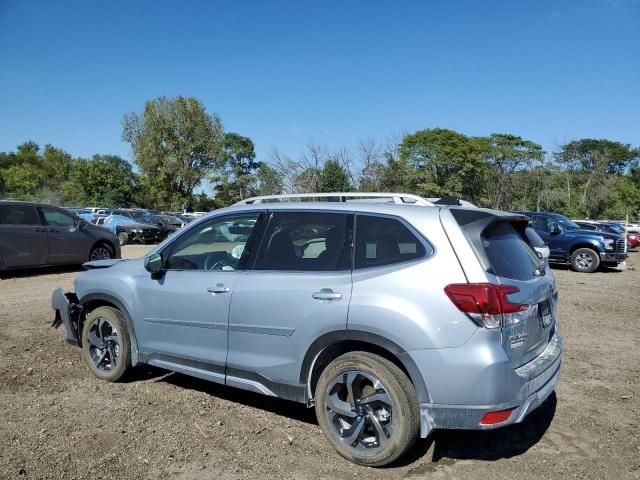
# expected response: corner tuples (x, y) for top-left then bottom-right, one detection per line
(0, 200), (120, 270)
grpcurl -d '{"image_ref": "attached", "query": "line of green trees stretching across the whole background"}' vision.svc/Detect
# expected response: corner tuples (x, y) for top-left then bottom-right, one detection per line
(0, 97), (640, 218)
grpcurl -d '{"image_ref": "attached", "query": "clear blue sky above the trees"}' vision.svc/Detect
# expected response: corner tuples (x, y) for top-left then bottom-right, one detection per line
(0, 0), (640, 165)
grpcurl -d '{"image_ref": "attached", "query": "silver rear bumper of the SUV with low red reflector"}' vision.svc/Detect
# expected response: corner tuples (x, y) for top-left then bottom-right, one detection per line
(412, 334), (562, 437)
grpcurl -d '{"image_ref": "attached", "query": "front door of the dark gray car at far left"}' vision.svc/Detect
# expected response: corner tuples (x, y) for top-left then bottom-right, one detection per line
(38, 207), (93, 265)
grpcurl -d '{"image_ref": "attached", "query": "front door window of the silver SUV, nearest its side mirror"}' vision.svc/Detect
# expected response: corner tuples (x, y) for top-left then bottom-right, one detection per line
(165, 212), (261, 271)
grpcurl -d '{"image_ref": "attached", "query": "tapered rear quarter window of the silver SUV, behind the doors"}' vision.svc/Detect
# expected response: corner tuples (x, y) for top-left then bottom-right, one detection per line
(355, 215), (433, 268)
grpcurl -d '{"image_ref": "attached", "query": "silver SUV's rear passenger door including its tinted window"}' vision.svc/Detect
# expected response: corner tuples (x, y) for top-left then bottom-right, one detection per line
(227, 211), (353, 400)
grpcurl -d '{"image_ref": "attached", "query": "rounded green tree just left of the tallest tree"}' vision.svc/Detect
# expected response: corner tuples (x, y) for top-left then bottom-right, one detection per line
(63, 155), (137, 207)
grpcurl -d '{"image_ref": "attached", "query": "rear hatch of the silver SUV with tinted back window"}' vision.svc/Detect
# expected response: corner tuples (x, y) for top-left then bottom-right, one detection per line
(452, 211), (557, 368)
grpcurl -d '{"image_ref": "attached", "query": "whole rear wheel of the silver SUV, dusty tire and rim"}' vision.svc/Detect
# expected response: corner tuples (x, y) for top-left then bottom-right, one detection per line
(315, 352), (420, 467)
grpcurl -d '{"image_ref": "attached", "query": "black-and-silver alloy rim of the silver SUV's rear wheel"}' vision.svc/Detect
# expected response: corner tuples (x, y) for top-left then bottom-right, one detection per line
(325, 370), (394, 451)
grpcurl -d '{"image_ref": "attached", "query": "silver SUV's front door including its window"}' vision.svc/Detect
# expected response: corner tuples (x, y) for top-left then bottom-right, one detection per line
(134, 212), (259, 383)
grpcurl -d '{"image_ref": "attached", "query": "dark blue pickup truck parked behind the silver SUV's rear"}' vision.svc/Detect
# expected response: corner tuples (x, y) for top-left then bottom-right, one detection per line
(517, 212), (627, 273)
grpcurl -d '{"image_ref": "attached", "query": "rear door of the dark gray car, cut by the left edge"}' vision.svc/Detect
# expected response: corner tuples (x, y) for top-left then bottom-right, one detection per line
(0, 203), (47, 268)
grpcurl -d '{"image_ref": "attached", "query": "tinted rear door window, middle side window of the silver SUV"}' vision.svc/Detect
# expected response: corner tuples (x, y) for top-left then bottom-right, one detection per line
(253, 211), (353, 272)
